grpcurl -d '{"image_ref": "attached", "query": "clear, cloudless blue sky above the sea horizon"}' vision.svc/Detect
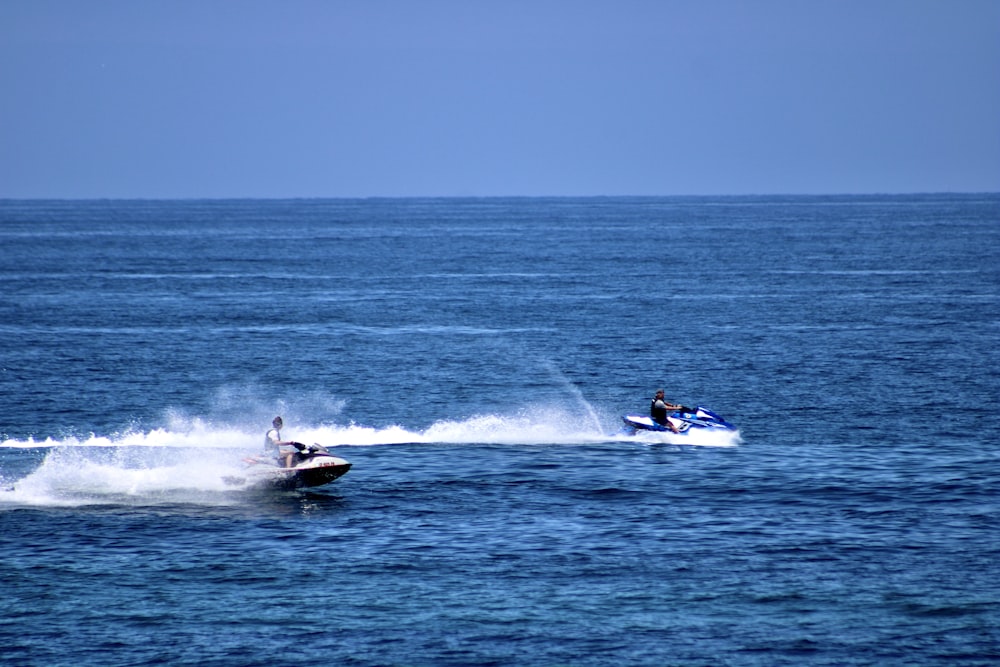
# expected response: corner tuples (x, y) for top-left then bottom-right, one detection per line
(0, 0), (1000, 198)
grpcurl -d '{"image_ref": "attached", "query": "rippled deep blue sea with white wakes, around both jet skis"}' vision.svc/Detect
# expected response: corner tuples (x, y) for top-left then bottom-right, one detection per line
(0, 195), (1000, 667)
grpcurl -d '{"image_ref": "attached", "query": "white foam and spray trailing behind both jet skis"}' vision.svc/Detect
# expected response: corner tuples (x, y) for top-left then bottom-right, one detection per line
(0, 407), (740, 505)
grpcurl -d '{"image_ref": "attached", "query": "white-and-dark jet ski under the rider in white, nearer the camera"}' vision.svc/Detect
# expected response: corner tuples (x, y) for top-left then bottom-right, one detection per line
(225, 442), (351, 489)
